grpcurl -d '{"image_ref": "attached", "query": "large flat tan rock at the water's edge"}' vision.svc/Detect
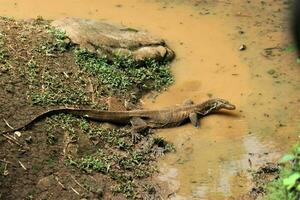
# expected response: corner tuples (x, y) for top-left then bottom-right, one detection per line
(51, 17), (174, 61)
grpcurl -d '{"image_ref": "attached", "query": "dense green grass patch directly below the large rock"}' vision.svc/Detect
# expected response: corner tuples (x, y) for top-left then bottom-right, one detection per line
(74, 49), (173, 94)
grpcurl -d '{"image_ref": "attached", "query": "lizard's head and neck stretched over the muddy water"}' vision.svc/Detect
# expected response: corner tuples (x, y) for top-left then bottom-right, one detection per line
(199, 99), (235, 115)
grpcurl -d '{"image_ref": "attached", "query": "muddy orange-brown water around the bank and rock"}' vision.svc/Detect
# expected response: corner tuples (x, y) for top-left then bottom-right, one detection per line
(0, 0), (300, 199)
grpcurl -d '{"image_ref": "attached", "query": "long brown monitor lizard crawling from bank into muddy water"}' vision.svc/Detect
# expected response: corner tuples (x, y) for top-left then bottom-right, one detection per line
(2, 98), (235, 134)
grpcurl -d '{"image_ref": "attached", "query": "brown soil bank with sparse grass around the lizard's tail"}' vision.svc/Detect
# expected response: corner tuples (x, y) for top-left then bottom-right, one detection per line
(0, 18), (172, 200)
